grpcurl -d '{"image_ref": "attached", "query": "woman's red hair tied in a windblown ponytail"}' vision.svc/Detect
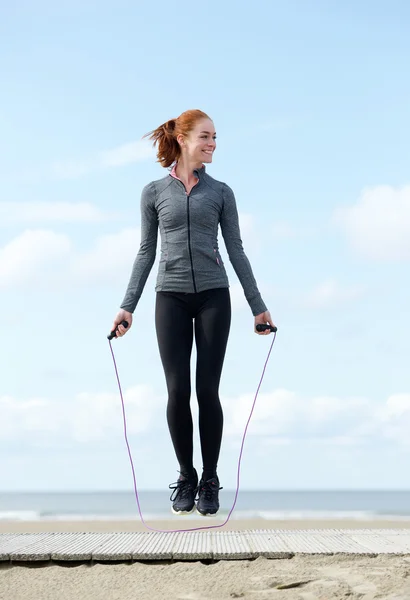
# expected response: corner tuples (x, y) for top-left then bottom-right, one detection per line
(143, 109), (209, 167)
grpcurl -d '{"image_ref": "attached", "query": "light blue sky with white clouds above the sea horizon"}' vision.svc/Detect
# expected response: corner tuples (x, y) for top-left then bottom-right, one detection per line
(0, 0), (410, 491)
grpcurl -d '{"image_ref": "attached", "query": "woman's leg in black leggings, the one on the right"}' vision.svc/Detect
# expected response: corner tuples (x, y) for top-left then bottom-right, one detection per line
(195, 288), (231, 481)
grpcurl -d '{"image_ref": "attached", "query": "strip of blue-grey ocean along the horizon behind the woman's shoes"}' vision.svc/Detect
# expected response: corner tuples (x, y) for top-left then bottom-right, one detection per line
(0, 490), (410, 521)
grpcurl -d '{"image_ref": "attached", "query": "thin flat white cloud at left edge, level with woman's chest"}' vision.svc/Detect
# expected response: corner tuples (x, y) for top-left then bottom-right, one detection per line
(0, 202), (119, 227)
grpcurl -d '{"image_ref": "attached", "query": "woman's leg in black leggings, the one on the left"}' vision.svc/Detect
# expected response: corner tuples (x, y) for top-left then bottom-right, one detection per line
(155, 292), (194, 478)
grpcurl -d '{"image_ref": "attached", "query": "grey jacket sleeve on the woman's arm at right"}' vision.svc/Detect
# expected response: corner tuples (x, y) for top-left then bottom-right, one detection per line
(220, 184), (268, 316)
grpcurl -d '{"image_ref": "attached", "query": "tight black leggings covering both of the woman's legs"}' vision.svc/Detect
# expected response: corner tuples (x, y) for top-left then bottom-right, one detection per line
(155, 288), (231, 477)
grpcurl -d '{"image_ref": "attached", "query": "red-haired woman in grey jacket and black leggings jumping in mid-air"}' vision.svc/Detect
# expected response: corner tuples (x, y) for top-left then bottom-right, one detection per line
(112, 110), (273, 515)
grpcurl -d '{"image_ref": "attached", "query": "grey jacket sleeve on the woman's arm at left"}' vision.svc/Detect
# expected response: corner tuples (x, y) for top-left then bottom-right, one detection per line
(120, 183), (158, 313)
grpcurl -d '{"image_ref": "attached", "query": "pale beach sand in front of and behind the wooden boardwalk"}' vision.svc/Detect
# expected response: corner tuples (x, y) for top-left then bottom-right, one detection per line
(0, 519), (410, 600)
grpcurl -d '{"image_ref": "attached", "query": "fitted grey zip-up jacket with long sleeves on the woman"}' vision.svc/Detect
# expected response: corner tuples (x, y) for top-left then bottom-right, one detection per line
(121, 167), (267, 316)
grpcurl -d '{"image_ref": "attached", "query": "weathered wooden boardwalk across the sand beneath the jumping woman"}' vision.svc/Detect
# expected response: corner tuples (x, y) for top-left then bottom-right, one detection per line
(0, 529), (410, 563)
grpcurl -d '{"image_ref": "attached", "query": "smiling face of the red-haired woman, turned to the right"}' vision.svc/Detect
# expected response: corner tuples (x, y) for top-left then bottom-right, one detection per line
(177, 119), (216, 166)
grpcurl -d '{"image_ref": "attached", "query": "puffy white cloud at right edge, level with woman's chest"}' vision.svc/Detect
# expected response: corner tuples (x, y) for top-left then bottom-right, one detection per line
(332, 185), (410, 261)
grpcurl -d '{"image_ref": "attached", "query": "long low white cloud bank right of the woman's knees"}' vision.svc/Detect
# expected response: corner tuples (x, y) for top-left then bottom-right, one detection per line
(223, 389), (410, 448)
